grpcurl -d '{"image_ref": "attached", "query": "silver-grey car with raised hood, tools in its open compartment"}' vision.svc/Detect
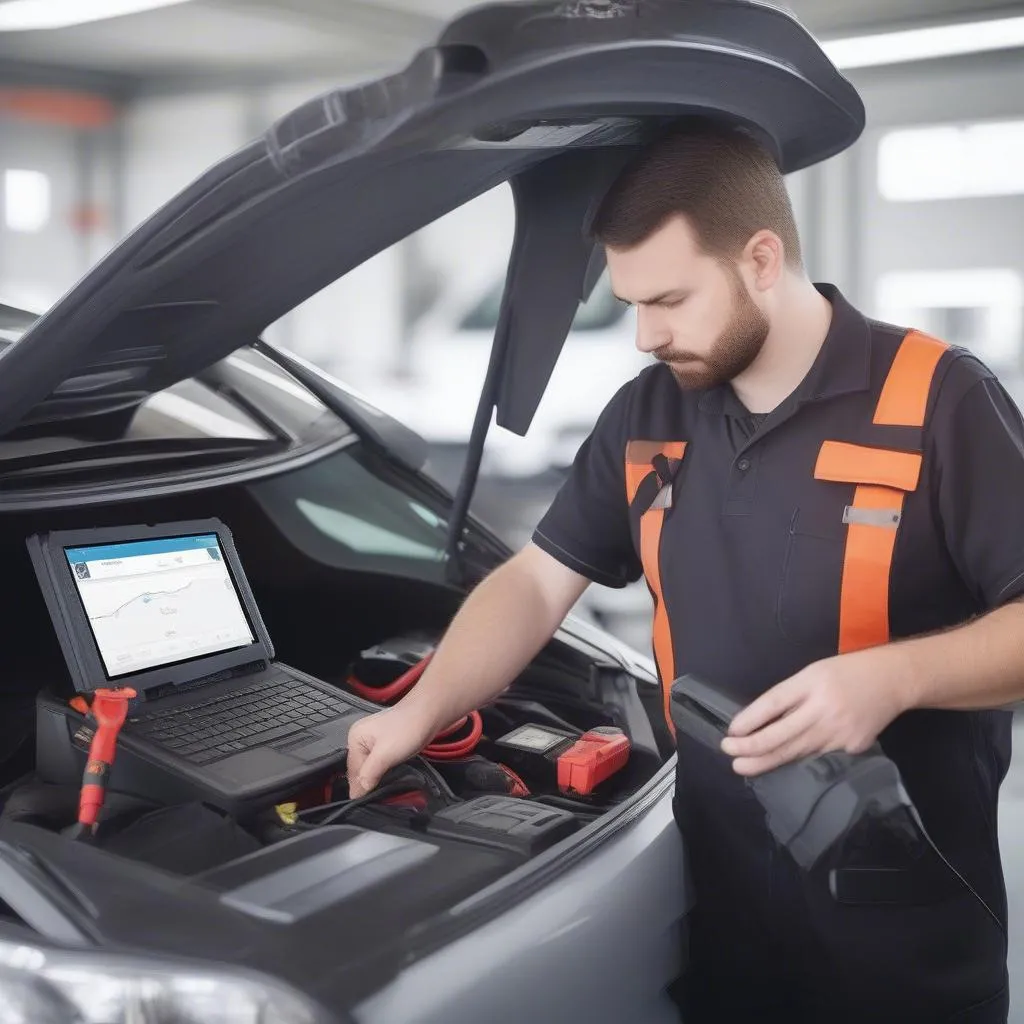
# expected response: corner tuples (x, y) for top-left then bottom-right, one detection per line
(0, 0), (863, 1024)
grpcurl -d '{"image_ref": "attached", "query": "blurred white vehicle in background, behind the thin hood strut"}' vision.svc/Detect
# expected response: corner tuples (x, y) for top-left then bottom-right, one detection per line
(369, 274), (652, 480)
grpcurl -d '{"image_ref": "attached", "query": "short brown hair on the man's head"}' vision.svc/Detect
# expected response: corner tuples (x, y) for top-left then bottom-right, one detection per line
(592, 123), (803, 266)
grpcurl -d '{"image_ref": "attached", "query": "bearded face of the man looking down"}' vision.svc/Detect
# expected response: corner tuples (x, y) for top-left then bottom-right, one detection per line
(607, 217), (769, 388)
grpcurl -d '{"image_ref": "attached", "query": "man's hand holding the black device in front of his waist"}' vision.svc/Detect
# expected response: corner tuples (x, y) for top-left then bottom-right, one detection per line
(722, 646), (910, 775)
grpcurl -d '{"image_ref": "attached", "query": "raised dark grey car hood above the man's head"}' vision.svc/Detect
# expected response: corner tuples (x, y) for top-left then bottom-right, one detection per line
(0, 0), (864, 434)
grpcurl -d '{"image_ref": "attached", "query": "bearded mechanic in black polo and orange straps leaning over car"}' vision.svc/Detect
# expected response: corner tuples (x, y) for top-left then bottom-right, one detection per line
(348, 125), (1024, 1024)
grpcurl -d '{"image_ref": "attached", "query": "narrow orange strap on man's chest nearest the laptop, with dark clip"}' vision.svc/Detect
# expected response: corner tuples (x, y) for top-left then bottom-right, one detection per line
(626, 441), (686, 738)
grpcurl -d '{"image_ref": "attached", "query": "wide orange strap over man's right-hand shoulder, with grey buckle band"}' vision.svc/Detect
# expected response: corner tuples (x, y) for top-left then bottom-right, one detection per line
(827, 331), (948, 654)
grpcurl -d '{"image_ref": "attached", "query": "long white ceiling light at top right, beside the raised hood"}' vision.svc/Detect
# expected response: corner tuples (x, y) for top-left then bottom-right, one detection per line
(821, 17), (1024, 70)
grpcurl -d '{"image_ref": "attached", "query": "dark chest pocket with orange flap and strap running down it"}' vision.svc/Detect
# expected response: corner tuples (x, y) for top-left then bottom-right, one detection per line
(776, 440), (922, 657)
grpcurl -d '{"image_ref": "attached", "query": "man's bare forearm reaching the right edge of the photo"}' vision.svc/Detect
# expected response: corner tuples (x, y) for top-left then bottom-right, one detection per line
(881, 600), (1024, 711)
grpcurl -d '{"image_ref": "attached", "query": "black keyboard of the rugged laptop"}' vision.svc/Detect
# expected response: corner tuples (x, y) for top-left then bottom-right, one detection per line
(129, 677), (349, 765)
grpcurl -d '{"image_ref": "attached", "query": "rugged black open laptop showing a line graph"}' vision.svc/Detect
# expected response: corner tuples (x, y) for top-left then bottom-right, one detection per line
(28, 519), (370, 813)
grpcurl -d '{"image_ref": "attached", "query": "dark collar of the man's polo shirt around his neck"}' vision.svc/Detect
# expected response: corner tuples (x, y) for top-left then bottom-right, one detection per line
(698, 283), (871, 417)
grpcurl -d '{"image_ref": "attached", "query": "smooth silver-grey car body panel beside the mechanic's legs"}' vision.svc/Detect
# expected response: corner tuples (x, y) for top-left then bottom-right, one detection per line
(352, 774), (692, 1024)
